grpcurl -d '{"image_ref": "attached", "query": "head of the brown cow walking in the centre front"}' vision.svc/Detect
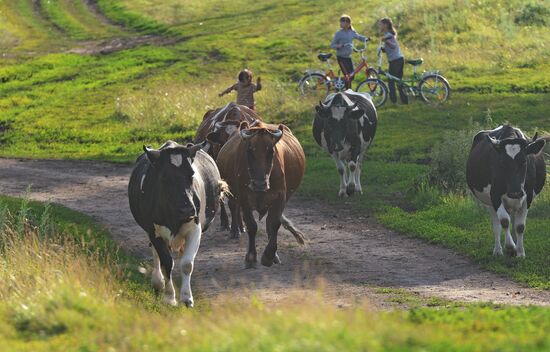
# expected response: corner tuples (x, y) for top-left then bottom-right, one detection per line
(239, 122), (284, 192)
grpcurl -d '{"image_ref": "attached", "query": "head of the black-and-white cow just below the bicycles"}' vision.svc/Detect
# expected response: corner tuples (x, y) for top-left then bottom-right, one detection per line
(315, 93), (364, 153)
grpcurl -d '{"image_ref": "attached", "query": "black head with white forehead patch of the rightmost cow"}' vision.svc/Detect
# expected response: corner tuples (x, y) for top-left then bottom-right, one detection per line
(487, 134), (545, 199)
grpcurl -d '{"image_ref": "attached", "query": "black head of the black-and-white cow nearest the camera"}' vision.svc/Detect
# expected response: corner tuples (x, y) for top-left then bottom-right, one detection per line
(143, 143), (205, 233)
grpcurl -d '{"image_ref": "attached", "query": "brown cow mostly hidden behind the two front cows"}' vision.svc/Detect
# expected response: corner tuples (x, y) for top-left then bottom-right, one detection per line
(194, 102), (259, 234)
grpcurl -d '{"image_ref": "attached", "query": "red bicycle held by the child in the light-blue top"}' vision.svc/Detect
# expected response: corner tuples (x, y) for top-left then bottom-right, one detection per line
(298, 38), (378, 96)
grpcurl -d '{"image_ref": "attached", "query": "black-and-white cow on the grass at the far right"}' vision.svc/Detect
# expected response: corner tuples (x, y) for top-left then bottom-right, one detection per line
(466, 125), (546, 257)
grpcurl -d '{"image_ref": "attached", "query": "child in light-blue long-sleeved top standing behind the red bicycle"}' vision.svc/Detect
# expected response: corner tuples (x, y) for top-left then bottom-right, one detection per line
(330, 15), (367, 88)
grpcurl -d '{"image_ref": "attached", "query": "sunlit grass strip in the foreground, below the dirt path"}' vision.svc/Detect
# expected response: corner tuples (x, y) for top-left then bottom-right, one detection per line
(0, 197), (550, 352)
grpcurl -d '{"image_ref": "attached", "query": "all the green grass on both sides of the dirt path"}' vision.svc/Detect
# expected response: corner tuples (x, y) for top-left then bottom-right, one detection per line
(0, 0), (550, 351)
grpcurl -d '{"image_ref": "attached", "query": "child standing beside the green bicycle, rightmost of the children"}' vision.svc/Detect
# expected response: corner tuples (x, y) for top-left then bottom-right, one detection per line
(378, 17), (409, 104)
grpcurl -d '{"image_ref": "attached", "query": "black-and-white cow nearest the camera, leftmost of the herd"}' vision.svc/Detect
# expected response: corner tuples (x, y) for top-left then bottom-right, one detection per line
(128, 141), (227, 307)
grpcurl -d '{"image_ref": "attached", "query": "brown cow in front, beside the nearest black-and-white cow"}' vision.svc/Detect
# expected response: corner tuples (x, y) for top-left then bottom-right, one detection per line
(208, 121), (305, 267)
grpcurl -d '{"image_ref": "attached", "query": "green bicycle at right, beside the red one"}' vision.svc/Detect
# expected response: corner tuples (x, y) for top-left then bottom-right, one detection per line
(356, 45), (451, 108)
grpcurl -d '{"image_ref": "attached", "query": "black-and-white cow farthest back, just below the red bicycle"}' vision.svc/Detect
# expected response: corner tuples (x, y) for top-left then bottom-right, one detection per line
(313, 90), (378, 197)
